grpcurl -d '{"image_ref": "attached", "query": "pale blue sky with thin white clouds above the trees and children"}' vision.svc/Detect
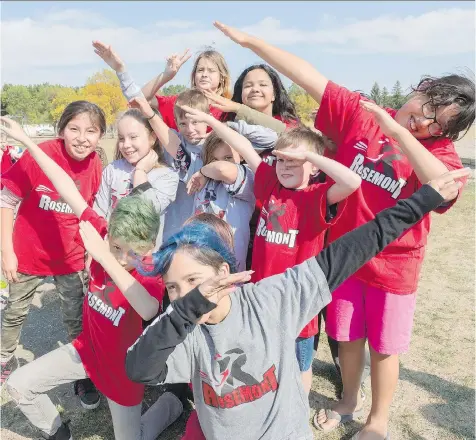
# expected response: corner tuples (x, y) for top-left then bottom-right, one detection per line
(1, 1), (475, 91)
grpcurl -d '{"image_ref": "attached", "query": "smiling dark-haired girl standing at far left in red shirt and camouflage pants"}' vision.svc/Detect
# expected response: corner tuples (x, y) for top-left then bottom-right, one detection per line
(1, 101), (106, 408)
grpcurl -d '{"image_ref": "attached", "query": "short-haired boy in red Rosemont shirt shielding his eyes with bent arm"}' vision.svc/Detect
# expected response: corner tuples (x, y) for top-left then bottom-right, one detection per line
(182, 106), (361, 393)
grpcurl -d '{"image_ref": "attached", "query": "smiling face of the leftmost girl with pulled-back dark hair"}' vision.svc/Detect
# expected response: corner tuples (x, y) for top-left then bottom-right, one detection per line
(60, 113), (101, 161)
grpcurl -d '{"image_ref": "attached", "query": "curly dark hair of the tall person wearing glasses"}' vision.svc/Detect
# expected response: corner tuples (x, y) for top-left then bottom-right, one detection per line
(412, 74), (475, 141)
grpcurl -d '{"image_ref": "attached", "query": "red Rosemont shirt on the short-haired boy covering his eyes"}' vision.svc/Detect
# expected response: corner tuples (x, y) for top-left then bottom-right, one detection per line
(251, 162), (345, 338)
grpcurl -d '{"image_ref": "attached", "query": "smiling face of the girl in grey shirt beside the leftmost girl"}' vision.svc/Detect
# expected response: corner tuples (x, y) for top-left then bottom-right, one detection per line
(117, 116), (156, 165)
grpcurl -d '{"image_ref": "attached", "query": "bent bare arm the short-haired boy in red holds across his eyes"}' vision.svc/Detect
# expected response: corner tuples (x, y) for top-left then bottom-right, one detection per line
(273, 150), (362, 205)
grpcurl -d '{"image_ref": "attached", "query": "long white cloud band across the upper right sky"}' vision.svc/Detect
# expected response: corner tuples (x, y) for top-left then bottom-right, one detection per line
(243, 8), (475, 56)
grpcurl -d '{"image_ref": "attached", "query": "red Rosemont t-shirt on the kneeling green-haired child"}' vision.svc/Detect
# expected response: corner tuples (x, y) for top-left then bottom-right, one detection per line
(73, 208), (164, 406)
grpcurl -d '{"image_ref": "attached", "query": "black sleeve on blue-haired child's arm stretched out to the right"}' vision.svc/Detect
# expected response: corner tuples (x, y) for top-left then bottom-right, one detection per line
(316, 185), (444, 292)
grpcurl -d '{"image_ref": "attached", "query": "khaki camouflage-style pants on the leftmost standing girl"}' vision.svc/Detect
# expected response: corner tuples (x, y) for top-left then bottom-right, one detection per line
(0, 271), (87, 362)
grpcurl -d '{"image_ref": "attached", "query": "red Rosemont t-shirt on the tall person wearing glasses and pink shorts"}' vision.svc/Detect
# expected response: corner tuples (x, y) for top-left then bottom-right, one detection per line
(315, 81), (462, 294)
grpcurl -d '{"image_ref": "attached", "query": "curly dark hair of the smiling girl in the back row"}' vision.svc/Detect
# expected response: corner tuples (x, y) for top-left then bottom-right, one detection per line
(222, 64), (299, 121)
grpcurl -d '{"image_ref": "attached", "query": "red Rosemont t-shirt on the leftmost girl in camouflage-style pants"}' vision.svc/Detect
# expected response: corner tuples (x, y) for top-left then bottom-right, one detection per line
(2, 139), (102, 276)
